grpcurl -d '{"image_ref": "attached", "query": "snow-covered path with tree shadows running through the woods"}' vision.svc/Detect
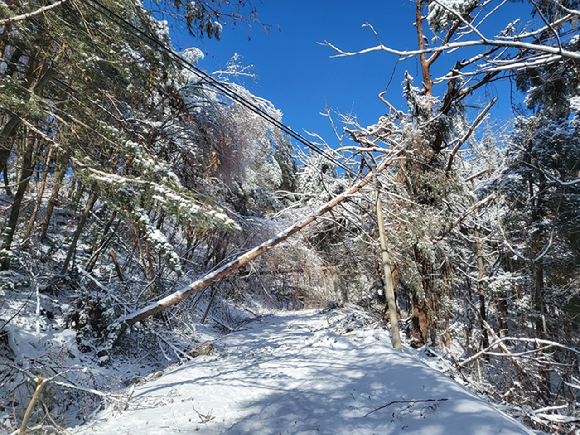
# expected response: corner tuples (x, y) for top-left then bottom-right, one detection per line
(75, 311), (532, 435)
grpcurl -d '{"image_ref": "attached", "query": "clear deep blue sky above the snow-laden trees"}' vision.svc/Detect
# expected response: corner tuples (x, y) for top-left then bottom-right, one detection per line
(173, 0), (522, 150)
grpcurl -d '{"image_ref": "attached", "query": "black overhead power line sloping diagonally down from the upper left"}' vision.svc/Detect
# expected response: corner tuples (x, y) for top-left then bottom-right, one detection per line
(80, 0), (356, 176)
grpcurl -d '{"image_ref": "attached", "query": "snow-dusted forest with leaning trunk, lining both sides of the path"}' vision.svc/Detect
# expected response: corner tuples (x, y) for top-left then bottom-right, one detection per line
(0, 0), (580, 434)
